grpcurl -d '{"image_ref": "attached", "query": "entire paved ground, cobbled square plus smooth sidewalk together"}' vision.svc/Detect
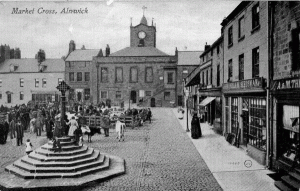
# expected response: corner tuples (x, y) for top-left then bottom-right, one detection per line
(0, 108), (278, 191)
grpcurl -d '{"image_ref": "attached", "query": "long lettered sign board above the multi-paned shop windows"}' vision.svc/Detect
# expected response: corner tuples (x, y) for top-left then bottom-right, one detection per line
(223, 78), (263, 90)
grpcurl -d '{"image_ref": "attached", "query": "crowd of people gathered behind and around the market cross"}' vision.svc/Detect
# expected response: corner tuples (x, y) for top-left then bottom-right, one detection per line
(0, 102), (152, 154)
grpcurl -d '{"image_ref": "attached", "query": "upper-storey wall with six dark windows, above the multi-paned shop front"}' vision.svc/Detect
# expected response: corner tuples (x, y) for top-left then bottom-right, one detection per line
(224, 1), (268, 83)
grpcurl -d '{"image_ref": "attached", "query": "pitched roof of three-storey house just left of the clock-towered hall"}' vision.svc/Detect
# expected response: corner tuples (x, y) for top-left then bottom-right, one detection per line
(66, 49), (99, 61)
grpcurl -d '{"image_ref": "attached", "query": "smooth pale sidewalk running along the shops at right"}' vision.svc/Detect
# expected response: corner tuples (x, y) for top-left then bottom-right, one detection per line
(173, 109), (279, 191)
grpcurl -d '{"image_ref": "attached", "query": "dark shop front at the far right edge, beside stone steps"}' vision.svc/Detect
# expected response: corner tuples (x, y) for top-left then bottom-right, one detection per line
(271, 79), (300, 172)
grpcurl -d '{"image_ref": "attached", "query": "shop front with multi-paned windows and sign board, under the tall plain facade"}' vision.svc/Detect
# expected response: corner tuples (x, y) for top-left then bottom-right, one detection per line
(222, 78), (267, 165)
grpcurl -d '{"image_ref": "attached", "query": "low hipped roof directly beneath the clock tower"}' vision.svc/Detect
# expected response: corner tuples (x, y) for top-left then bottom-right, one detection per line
(109, 47), (169, 57)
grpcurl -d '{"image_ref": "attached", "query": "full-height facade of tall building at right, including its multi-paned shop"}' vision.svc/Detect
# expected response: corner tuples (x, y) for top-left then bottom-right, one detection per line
(221, 1), (269, 164)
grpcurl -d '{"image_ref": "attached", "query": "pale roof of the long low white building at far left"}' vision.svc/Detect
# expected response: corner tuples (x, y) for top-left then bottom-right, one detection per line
(0, 58), (65, 73)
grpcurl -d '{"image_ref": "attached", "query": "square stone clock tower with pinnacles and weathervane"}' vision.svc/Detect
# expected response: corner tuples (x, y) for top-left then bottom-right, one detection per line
(130, 7), (156, 47)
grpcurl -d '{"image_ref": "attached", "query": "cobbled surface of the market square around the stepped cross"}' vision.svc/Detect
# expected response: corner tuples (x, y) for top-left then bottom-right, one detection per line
(0, 108), (222, 191)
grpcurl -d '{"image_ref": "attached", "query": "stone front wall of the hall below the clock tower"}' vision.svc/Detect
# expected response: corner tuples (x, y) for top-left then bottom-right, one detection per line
(91, 56), (177, 107)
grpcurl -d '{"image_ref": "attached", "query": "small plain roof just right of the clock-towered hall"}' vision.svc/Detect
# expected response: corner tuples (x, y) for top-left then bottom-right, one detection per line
(177, 51), (203, 65)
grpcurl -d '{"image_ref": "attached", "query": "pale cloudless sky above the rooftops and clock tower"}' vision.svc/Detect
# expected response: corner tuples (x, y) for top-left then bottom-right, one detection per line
(0, 0), (241, 58)
